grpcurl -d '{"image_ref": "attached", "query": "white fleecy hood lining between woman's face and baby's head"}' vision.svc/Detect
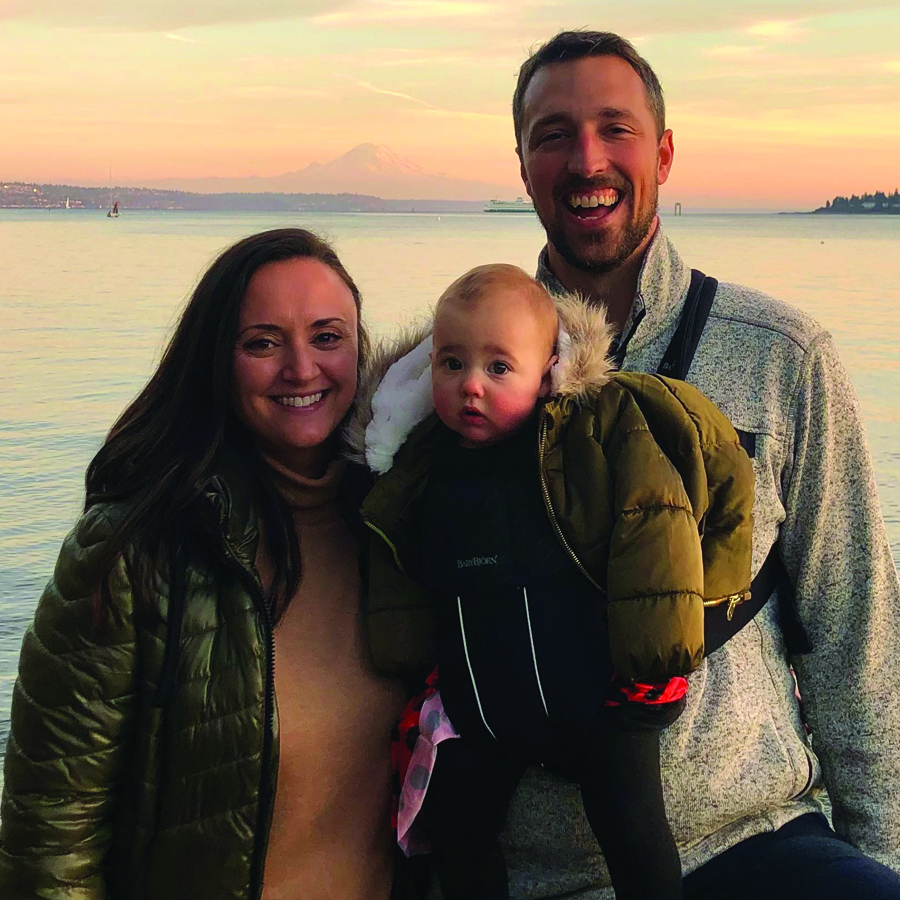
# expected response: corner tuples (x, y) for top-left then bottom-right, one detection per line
(366, 334), (434, 475)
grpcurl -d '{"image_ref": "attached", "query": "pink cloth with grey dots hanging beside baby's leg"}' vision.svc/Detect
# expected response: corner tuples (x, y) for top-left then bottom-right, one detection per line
(397, 691), (459, 856)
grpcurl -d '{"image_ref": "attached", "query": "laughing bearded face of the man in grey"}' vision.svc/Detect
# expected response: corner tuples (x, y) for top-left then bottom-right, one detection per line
(519, 56), (673, 274)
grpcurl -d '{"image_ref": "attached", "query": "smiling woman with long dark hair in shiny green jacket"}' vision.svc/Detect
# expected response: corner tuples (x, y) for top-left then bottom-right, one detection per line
(0, 229), (403, 900)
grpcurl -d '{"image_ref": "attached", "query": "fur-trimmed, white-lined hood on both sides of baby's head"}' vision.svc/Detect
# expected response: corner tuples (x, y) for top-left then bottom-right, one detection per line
(344, 294), (614, 474)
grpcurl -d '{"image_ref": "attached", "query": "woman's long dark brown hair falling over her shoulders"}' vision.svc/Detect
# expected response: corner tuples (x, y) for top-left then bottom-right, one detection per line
(84, 228), (368, 620)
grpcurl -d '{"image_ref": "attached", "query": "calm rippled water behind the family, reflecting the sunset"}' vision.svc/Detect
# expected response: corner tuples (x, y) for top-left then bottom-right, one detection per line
(0, 210), (900, 752)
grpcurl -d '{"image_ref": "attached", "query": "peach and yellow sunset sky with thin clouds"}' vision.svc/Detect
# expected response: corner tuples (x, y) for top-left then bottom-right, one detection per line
(0, 0), (900, 208)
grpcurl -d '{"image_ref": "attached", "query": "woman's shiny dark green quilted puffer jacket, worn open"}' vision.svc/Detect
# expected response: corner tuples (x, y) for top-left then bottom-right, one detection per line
(0, 478), (278, 900)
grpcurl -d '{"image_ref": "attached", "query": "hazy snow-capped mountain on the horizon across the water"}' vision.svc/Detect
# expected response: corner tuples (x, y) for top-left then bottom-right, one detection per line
(146, 144), (522, 202)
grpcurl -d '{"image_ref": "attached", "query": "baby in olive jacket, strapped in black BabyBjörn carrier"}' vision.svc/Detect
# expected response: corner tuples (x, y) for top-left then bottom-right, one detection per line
(363, 265), (753, 900)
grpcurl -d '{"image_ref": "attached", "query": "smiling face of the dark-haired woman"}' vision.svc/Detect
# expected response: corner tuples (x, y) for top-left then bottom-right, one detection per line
(232, 257), (358, 476)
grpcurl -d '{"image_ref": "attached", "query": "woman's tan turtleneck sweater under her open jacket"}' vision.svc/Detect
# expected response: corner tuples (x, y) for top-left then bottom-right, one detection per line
(257, 460), (403, 900)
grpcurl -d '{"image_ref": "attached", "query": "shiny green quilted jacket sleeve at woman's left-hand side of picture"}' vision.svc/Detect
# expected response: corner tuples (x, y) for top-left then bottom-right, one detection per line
(0, 507), (135, 900)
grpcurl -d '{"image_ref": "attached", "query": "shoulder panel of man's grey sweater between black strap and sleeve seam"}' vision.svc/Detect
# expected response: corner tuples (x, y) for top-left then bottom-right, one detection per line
(710, 281), (825, 354)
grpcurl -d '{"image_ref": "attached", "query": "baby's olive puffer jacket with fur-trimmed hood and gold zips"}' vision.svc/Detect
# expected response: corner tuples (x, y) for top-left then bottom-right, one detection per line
(354, 299), (753, 680)
